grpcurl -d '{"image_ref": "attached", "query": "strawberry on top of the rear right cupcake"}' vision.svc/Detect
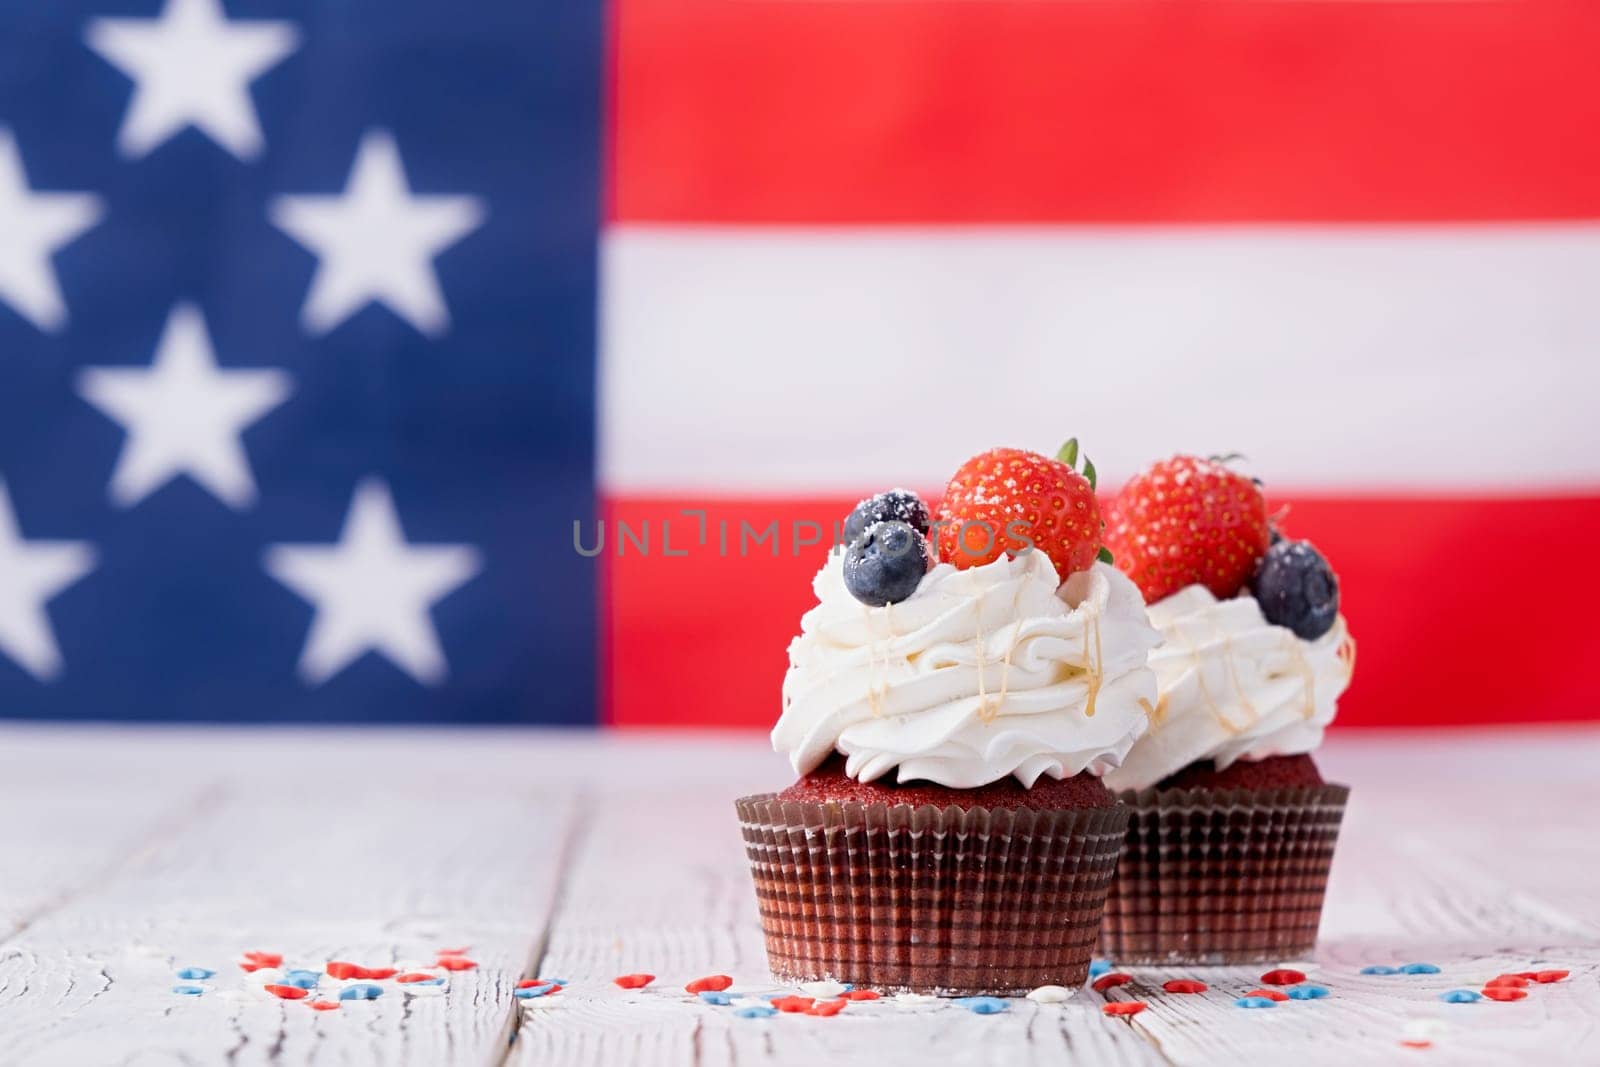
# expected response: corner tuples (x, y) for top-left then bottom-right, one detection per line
(1106, 456), (1272, 603)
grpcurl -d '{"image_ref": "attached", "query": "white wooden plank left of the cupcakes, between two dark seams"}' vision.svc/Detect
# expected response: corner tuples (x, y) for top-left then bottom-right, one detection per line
(0, 737), (571, 1064)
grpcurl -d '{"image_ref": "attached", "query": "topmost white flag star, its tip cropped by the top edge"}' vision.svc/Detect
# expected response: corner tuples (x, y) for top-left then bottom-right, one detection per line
(83, 0), (299, 160)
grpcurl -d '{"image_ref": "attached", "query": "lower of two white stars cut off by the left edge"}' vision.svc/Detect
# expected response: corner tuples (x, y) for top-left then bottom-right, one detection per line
(0, 482), (94, 681)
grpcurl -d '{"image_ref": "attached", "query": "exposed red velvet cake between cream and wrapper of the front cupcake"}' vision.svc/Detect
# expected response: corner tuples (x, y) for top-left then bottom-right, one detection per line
(778, 753), (1117, 811)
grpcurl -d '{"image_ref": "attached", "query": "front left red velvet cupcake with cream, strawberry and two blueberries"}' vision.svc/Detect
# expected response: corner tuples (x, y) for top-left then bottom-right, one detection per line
(738, 450), (1160, 995)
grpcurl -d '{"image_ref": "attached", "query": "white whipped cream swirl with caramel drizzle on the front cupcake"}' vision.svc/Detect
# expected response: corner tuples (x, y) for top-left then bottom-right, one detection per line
(773, 550), (1160, 789)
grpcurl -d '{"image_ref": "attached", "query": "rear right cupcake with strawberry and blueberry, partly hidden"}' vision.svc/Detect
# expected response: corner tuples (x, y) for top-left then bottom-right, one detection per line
(1101, 456), (1355, 963)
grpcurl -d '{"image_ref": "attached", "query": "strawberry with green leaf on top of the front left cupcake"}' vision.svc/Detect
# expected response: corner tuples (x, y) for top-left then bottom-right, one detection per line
(939, 438), (1104, 581)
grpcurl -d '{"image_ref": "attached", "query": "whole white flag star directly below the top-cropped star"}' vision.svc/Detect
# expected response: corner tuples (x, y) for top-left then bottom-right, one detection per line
(78, 304), (291, 510)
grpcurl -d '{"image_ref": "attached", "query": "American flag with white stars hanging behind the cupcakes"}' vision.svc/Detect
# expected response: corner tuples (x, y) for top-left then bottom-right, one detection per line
(0, 0), (1600, 728)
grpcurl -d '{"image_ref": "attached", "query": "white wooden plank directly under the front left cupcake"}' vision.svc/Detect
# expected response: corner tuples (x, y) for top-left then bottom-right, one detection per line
(512, 790), (1166, 1067)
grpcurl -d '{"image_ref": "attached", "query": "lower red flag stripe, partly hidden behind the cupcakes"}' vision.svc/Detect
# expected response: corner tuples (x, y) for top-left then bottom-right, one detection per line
(598, 496), (1600, 728)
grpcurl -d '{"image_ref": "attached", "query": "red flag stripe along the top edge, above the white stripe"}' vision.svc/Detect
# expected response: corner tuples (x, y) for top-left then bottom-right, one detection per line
(611, 0), (1600, 222)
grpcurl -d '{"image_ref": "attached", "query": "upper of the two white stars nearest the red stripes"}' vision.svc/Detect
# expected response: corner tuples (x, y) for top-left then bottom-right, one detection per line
(272, 130), (485, 336)
